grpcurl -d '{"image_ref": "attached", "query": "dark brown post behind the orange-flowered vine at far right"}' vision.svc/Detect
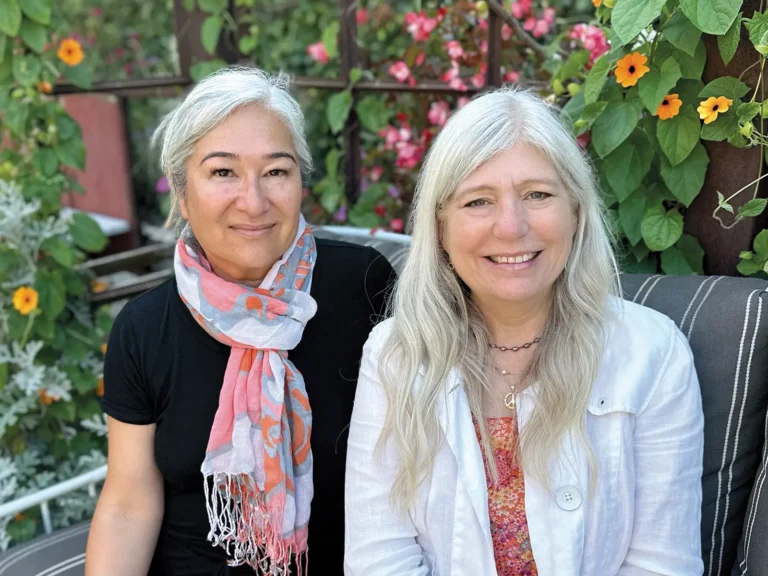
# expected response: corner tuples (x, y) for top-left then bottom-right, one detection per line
(685, 0), (768, 276)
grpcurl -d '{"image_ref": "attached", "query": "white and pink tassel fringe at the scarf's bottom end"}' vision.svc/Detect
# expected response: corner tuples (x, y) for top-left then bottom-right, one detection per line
(203, 473), (309, 576)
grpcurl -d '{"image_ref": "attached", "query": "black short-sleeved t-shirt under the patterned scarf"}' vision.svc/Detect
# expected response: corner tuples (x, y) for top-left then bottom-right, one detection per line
(102, 238), (394, 576)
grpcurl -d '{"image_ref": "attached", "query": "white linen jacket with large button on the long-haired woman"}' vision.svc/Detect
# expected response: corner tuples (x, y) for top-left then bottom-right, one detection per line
(344, 299), (704, 576)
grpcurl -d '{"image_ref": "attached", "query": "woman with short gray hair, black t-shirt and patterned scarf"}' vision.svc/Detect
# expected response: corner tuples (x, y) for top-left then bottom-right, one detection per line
(86, 68), (393, 576)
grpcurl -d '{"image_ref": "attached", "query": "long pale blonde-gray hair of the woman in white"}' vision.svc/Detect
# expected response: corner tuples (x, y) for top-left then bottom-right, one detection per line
(379, 89), (619, 510)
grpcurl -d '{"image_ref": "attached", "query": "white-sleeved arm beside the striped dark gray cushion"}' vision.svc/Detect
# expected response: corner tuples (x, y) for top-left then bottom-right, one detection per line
(619, 326), (704, 576)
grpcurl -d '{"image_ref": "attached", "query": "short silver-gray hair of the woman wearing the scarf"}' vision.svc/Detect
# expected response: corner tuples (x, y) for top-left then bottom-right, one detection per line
(152, 66), (312, 225)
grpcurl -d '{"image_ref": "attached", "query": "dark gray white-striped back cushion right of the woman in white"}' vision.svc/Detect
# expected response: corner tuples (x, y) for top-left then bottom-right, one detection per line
(622, 274), (768, 576)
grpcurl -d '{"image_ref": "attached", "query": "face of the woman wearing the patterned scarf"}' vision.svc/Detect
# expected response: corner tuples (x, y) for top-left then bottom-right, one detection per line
(180, 105), (302, 282)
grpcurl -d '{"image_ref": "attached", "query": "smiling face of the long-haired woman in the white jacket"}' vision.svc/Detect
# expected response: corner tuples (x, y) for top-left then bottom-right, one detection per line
(440, 144), (578, 304)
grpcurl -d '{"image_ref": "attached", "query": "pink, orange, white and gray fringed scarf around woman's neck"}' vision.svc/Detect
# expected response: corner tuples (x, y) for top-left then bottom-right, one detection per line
(174, 217), (317, 574)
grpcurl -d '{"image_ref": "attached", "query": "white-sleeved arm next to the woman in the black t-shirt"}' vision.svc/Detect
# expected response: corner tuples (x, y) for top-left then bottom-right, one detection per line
(344, 325), (429, 576)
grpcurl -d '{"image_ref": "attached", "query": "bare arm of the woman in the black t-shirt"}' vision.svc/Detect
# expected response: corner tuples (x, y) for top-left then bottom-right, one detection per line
(85, 418), (163, 576)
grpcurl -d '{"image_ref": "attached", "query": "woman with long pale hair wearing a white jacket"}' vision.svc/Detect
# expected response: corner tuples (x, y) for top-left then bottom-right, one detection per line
(345, 90), (703, 576)
